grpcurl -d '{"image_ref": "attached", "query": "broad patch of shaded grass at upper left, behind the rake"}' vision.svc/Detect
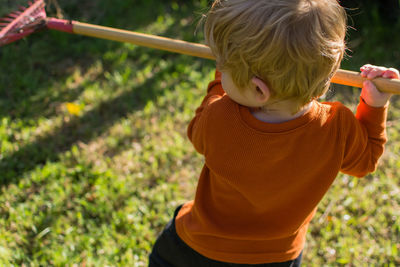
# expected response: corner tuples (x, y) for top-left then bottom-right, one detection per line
(0, 0), (205, 121)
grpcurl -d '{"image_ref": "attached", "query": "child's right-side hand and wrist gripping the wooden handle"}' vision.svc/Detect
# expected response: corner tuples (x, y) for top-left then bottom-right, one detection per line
(360, 64), (400, 107)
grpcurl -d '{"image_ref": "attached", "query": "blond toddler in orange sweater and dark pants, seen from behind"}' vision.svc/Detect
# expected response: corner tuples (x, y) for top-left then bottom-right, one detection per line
(149, 0), (399, 267)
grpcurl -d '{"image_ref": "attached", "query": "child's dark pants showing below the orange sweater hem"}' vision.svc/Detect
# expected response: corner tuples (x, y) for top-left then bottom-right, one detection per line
(149, 206), (302, 267)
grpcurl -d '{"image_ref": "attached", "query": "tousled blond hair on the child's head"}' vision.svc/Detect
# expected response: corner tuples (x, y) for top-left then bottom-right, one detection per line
(204, 0), (346, 110)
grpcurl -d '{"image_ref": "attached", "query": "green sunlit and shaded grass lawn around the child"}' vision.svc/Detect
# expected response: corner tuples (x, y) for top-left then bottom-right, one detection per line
(0, 0), (400, 267)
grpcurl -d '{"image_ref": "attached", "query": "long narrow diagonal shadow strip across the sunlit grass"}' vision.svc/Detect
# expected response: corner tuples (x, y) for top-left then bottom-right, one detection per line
(0, 52), (209, 186)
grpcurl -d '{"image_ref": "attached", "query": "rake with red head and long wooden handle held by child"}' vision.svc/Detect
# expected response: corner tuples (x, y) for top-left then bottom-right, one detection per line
(0, 0), (400, 94)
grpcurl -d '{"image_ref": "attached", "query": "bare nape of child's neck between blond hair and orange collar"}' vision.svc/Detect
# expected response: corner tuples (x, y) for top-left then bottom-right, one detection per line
(250, 100), (313, 123)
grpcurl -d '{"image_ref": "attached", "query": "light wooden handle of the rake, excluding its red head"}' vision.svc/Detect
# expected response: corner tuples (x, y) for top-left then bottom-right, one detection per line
(69, 21), (400, 94)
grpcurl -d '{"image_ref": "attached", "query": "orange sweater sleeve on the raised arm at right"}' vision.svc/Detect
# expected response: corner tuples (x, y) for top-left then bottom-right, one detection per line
(341, 98), (387, 177)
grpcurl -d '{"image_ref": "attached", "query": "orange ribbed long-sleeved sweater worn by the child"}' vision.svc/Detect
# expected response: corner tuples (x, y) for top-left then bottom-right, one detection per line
(175, 72), (387, 264)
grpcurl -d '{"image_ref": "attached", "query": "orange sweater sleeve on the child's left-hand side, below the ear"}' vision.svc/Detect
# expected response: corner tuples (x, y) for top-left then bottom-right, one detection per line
(187, 70), (225, 154)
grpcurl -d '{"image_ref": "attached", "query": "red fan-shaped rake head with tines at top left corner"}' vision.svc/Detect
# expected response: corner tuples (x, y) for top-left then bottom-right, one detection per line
(0, 0), (46, 46)
